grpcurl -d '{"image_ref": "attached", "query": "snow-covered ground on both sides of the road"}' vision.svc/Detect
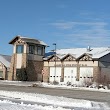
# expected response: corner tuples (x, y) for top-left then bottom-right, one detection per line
(0, 81), (110, 110)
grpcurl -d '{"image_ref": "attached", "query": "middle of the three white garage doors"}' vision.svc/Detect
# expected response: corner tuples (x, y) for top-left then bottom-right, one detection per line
(64, 67), (77, 84)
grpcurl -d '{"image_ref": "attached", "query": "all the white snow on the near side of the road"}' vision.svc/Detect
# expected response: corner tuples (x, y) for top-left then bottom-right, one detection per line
(0, 90), (110, 110)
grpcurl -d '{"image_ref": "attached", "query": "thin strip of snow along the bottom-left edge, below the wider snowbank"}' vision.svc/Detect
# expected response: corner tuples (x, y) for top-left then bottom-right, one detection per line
(0, 100), (70, 110)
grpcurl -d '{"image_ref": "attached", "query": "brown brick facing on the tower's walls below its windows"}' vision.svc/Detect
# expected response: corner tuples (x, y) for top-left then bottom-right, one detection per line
(8, 53), (43, 81)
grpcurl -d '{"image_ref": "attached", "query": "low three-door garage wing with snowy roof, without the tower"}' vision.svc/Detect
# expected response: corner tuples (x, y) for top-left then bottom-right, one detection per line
(43, 46), (110, 86)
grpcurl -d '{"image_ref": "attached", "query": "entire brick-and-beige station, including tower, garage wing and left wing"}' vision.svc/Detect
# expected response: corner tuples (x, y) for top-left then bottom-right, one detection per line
(0, 36), (110, 86)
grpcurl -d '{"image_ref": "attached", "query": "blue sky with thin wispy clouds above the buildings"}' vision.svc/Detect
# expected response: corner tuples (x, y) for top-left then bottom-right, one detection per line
(0, 0), (110, 55)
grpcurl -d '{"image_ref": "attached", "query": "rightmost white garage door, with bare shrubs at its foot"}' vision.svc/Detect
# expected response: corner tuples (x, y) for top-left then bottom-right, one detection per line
(79, 67), (93, 85)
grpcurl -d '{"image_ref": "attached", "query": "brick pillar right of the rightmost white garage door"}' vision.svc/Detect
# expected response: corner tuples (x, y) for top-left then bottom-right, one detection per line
(93, 67), (101, 84)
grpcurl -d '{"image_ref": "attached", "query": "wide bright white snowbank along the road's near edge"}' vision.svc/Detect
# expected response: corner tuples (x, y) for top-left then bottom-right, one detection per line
(0, 91), (108, 110)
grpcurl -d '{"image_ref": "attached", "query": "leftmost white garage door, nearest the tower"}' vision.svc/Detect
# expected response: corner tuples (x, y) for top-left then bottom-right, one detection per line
(50, 67), (61, 82)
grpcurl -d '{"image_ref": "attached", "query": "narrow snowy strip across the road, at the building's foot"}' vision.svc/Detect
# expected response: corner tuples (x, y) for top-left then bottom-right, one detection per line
(0, 80), (110, 92)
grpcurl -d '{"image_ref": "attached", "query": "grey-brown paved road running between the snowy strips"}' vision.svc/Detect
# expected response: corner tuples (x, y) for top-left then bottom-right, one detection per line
(0, 85), (110, 105)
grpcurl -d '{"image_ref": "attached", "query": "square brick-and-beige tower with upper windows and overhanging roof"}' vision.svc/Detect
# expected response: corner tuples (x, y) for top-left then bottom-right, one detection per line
(8, 36), (47, 81)
